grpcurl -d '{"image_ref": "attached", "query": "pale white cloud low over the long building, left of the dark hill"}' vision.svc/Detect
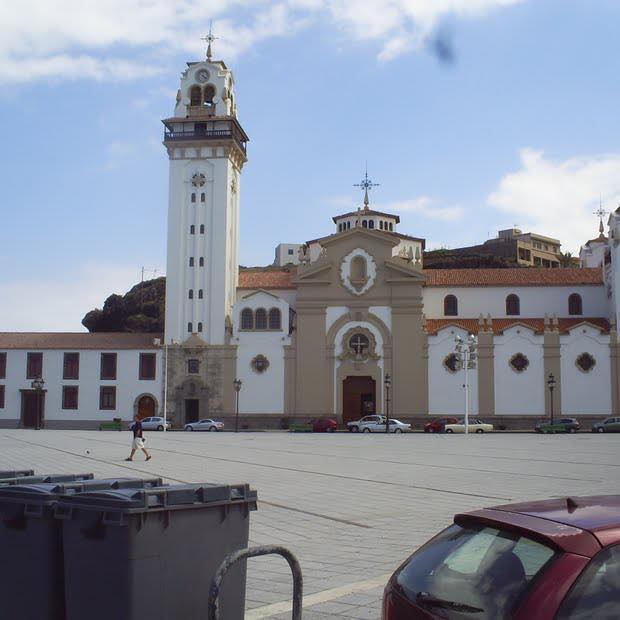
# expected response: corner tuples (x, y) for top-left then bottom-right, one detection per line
(0, 264), (148, 332)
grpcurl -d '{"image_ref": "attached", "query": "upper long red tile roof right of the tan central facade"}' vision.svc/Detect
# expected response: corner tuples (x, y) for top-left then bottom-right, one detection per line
(423, 267), (603, 286)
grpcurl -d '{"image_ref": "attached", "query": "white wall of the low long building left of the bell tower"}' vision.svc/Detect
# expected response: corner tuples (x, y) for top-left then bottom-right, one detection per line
(0, 349), (163, 422)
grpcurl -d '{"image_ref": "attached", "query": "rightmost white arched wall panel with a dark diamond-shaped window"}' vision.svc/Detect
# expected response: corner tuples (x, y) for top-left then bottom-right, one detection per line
(560, 325), (611, 416)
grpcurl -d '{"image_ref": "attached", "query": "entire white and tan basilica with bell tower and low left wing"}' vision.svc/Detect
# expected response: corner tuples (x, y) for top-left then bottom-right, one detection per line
(0, 50), (620, 428)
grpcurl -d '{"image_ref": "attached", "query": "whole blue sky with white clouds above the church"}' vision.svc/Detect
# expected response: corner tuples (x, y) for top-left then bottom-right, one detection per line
(0, 0), (620, 331)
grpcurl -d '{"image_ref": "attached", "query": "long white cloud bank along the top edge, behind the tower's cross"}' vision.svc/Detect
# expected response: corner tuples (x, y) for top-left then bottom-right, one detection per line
(0, 0), (524, 83)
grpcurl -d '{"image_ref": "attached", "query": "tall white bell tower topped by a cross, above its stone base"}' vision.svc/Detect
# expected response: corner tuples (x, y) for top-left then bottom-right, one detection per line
(163, 41), (248, 346)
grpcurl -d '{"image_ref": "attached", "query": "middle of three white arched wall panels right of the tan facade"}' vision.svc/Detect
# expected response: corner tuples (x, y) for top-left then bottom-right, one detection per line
(495, 325), (546, 416)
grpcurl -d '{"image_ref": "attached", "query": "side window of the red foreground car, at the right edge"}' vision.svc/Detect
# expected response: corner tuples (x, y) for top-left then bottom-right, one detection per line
(556, 545), (620, 620)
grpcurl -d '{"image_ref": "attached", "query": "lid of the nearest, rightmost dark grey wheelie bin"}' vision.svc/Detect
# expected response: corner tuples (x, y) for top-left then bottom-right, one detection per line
(58, 484), (257, 513)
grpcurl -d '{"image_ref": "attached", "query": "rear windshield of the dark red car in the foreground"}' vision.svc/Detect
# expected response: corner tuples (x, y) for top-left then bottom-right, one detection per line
(396, 525), (555, 620)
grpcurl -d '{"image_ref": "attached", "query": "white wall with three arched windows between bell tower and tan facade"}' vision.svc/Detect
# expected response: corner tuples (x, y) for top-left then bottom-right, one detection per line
(231, 291), (291, 414)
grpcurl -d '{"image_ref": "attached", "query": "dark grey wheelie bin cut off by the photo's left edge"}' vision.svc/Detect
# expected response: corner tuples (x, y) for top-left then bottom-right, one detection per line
(0, 474), (162, 620)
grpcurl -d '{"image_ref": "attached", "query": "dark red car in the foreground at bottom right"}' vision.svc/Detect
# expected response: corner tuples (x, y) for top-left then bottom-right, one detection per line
(383, 495), (620, 620)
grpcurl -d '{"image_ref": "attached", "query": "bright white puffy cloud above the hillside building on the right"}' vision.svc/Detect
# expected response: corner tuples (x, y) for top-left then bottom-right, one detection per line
(487, 149), (620, 254)
